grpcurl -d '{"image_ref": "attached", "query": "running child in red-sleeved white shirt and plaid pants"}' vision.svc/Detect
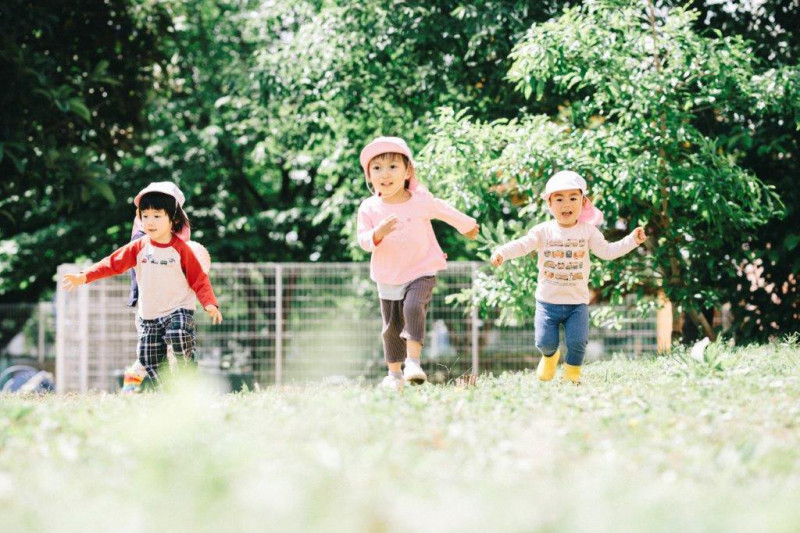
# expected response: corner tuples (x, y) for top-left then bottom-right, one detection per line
(62, 182), (222, 381)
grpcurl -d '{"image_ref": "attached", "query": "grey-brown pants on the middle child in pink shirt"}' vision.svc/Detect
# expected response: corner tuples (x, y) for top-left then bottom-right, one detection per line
(381, 276), (436, 363)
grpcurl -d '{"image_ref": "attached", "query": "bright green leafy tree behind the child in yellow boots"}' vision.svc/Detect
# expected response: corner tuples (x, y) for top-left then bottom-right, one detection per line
(427, 1), (798, 338)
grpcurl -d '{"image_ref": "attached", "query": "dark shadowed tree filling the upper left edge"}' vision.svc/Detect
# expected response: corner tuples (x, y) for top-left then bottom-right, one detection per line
(0, 0), (166, 302)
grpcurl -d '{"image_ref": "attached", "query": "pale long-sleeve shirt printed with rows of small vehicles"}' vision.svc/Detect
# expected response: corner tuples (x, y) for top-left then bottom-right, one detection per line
(495, 220), (638, 305)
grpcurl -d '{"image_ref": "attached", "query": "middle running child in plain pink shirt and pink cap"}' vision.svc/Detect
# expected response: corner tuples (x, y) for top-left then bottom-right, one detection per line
(358, 137), (478, 390)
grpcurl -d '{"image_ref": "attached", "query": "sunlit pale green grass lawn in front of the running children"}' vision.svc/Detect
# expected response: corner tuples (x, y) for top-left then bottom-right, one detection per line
(0, 339), (800, 532)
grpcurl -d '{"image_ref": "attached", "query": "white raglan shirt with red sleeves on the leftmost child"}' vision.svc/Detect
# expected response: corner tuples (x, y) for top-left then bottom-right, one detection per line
(84, 235), (219, 320)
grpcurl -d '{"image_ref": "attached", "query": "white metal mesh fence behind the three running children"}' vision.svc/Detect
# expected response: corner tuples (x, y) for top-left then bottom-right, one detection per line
(56, 262), (656, 392)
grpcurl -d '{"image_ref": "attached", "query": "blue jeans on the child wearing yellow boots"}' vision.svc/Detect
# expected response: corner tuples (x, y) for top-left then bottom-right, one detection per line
(533, 300), (589, 366)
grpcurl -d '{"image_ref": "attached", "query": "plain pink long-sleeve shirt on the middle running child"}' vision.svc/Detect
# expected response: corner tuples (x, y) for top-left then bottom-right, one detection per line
(358, 191), (476, 285)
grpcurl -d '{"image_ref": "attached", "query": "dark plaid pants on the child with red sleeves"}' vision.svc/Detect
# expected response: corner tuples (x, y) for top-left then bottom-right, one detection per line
(136, 309), (195, 382)
